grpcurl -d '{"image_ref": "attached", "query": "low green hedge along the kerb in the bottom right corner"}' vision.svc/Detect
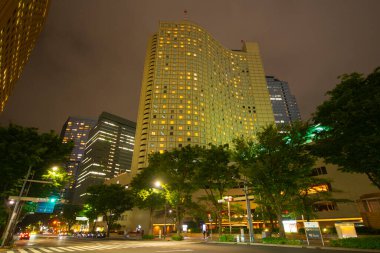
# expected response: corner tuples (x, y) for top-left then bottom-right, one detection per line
(330, 236), (380, 249)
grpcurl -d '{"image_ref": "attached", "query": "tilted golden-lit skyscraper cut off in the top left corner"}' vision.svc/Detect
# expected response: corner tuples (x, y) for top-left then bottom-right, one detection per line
(0, 0), (49, 112)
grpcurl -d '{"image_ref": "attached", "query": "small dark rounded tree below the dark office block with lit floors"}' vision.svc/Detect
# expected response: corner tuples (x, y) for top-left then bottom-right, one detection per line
(85, 184), (133, 237)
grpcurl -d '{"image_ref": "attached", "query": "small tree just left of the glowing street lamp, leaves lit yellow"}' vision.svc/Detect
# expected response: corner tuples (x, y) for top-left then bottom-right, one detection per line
(130, 169), (166, 234)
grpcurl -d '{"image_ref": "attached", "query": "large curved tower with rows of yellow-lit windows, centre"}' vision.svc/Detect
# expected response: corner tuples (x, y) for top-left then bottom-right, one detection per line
(132, 21), (274, 172)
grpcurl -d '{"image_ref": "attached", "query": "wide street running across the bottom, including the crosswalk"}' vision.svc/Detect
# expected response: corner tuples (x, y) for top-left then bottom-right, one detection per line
(1, 237), (376, 253)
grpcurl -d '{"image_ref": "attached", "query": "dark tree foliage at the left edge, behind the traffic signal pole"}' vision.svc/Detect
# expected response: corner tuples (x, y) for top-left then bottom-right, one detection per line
(0, 124), (73, 231)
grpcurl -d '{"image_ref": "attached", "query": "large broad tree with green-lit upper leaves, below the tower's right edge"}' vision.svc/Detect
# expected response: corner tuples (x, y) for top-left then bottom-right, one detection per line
(235, 124), (315, 237)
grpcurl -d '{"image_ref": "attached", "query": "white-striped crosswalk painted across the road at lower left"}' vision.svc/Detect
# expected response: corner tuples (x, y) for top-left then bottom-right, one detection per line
(6, 242), (185, 253)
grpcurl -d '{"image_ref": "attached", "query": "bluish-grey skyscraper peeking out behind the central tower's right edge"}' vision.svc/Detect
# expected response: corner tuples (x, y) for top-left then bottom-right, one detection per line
(266, 76), (301, 126)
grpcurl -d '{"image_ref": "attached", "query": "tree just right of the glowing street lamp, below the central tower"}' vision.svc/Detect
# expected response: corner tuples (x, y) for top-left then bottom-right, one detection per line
(144, 146), (201, 235)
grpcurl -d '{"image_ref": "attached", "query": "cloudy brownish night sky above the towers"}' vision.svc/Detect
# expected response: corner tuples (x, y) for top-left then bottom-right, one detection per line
(0, 0), (380, 132)
